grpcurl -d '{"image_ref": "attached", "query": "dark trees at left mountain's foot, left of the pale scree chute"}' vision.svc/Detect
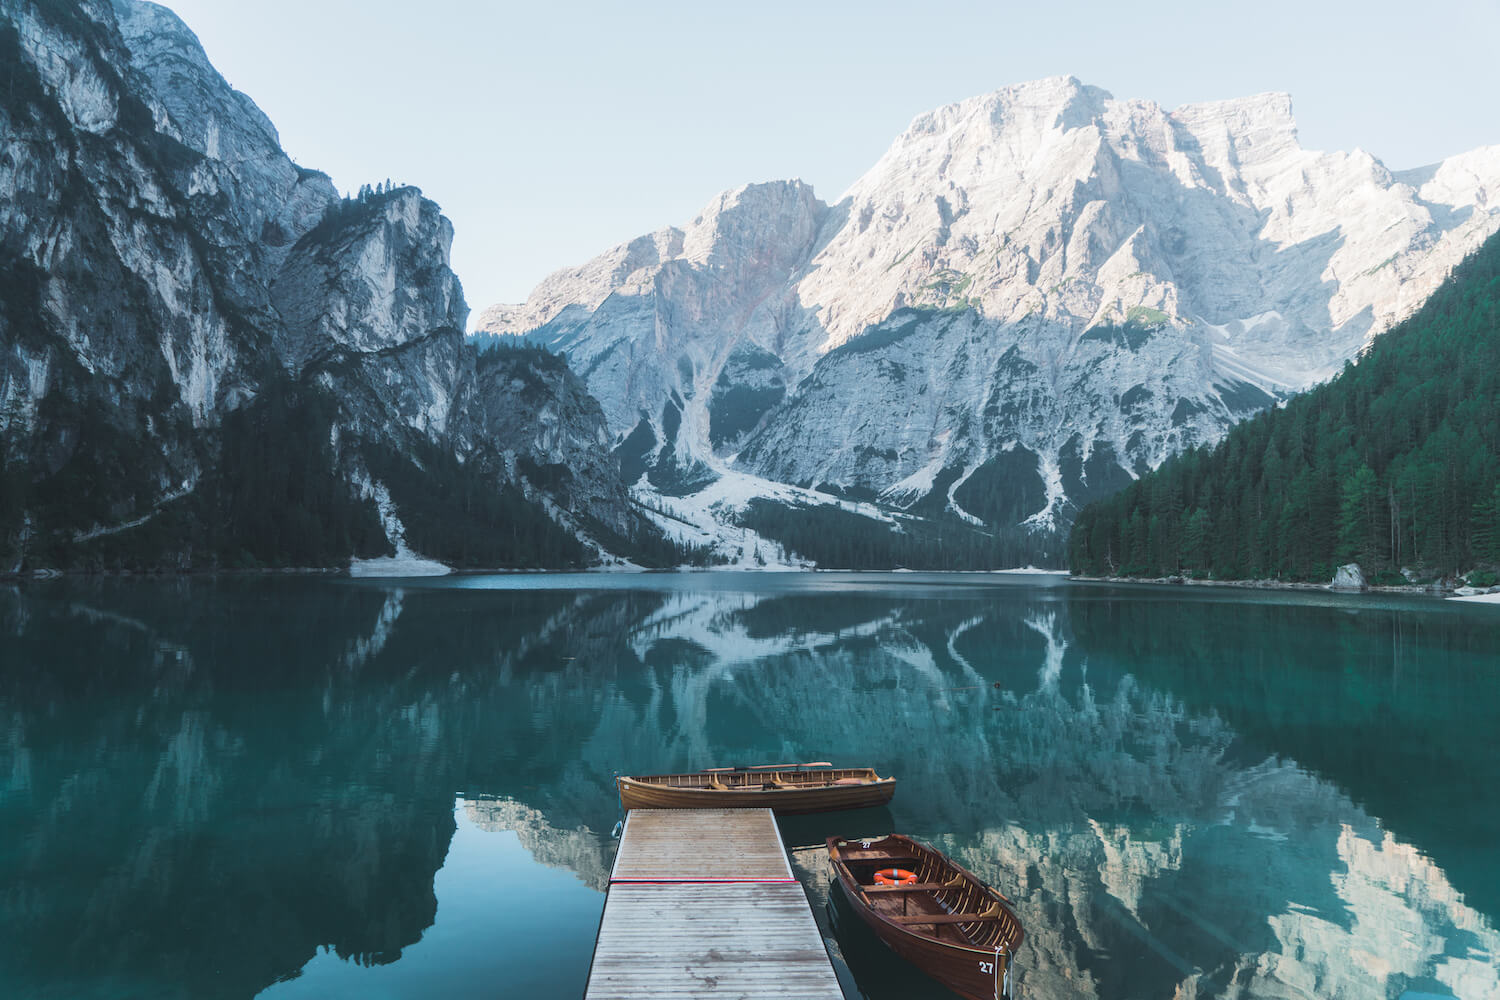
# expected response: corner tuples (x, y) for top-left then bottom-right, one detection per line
(0, 376), (390, 571)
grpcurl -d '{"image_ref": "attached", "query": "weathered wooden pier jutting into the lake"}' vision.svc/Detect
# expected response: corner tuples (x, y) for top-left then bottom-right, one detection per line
(584, 810), (843, 1000)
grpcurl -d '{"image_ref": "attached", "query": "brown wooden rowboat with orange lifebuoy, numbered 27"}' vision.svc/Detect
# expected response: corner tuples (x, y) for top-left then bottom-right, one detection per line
(828, 835), (1022, 1000)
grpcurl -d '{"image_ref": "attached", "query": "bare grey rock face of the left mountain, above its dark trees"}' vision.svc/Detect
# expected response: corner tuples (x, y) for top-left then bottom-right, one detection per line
(0, 0), (629, 570)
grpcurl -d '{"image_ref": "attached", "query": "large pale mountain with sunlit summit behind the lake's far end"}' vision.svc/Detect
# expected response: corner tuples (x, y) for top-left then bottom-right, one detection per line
(477, 78), (1500, 560)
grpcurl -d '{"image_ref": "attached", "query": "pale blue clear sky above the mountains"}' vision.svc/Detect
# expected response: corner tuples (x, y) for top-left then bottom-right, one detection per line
(168, 0), (1500, 310)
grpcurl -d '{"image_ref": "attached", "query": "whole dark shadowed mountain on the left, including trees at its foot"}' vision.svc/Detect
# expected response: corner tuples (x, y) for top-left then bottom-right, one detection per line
(0, 0), (659, 571)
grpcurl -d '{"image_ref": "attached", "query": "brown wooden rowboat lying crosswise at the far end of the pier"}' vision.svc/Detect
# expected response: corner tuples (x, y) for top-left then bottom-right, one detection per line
(615, 762), (896, 813)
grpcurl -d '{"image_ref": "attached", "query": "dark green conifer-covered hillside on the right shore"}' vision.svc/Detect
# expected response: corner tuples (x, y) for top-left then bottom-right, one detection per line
(1068, 230), (1500, 582)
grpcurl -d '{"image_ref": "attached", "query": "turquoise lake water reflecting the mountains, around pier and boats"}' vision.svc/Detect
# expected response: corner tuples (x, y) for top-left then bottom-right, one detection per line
(0, 573), (1500, 1000)
